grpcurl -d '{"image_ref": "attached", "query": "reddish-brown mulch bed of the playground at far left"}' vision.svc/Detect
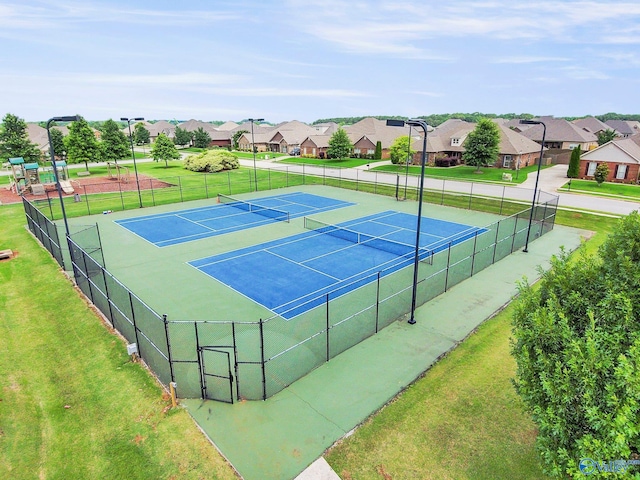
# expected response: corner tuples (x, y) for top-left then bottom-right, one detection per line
(0, 174), (173, 204)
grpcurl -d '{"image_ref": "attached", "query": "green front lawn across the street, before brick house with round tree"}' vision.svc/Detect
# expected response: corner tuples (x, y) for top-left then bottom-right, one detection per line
(373, 165), (548, 184)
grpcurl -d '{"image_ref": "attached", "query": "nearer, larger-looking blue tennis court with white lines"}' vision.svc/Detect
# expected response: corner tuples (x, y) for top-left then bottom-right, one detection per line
(189, 210), (486, 319)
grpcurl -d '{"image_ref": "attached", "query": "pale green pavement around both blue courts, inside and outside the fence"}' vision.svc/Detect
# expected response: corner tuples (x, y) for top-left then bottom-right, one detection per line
(65, 186), (582, 480)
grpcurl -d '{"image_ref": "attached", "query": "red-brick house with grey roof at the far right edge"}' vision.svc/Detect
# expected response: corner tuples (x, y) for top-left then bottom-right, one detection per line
(580, 134), (640, 183)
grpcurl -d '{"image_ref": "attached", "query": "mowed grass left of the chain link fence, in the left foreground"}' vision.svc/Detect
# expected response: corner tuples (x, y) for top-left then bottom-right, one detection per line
(0, 205), (237, 480)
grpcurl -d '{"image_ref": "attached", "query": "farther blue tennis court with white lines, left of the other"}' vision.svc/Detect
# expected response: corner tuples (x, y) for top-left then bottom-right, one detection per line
(116, 192), (353, 247)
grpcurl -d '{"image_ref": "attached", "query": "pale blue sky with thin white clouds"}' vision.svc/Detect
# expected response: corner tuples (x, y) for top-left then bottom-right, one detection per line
(0, 0), (640, 123)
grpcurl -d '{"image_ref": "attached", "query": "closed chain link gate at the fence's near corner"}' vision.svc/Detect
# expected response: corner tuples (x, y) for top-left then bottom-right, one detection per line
(198, 347), (233, 403)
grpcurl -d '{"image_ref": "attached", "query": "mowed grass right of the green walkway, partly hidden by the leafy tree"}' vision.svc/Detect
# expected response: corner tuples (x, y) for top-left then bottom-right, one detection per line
(325, 212), (616, 480)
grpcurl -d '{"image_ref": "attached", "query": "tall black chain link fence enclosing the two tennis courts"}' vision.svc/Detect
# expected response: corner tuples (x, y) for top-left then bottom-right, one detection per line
(24, 171), (558, 403)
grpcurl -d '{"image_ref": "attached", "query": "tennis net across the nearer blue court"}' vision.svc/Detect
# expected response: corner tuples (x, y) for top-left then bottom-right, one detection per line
(304, 217), (433, 264)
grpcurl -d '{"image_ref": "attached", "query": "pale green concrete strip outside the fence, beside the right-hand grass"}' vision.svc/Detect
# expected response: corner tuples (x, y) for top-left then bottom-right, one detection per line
(182, 222), (587, 480)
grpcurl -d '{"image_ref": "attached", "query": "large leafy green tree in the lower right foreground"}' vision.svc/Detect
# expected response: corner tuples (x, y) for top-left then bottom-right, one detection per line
(511, 212), (640, 478)
